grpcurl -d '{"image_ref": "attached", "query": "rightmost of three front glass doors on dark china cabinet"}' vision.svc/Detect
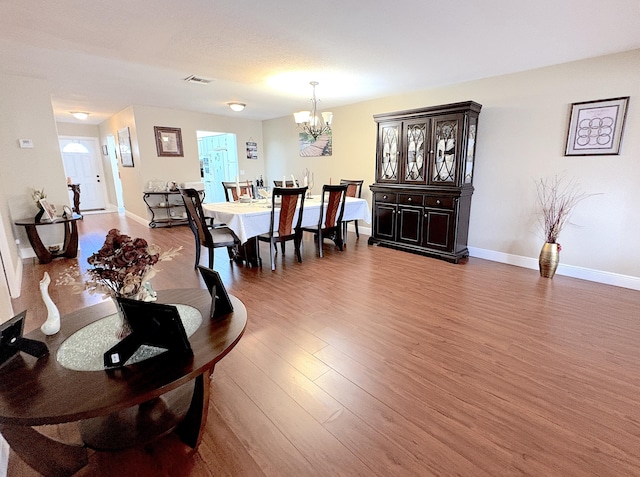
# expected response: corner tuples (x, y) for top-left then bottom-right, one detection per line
(430, 115), (461, 185)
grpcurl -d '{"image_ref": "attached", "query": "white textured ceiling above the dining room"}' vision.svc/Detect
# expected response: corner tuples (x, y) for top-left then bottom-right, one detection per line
(0, 0), (640, 124)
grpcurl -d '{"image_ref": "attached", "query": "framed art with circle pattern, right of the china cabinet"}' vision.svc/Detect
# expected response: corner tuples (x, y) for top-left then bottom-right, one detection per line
(564, 96), (629, 156)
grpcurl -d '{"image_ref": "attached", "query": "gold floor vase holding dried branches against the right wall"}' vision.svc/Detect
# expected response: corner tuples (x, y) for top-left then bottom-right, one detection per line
(536, 176), (594, 278)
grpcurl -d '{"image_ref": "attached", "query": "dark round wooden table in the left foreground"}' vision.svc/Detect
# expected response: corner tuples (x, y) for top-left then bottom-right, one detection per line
(0, 289), (247, 475)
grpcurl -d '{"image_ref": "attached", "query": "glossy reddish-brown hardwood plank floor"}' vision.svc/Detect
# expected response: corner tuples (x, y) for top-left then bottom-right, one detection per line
(9, 214), (640, 477)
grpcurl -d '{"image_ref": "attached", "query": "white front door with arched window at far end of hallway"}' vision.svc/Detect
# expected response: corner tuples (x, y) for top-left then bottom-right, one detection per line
(59, 136), (106, 211)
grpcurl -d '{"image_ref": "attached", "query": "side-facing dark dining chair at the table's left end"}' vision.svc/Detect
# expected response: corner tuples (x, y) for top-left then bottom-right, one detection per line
(180, 189), (240, 268)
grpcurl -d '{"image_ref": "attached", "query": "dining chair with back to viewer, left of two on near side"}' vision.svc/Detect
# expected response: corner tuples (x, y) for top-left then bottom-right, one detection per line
(258, 187), (307, 270)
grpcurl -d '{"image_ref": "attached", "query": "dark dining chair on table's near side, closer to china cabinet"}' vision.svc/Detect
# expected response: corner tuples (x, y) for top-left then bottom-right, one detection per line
(302, 184), (347, 258)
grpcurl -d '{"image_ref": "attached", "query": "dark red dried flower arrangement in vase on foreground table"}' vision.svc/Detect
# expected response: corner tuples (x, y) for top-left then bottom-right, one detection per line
(84, 229), (182, 338)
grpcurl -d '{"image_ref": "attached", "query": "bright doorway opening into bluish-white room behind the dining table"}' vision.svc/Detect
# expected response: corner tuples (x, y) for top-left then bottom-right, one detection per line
(197, 131), (238, 202)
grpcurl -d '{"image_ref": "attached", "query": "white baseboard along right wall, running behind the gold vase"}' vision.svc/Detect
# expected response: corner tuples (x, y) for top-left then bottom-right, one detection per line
(469, 247), (640, 290)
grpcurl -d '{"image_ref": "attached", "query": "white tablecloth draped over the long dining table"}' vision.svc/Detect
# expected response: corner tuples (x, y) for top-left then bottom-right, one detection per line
(202, 196), (371, 243)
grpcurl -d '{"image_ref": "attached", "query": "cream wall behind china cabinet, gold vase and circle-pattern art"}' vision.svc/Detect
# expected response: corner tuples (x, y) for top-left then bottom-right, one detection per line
(264, 50), (640, 283)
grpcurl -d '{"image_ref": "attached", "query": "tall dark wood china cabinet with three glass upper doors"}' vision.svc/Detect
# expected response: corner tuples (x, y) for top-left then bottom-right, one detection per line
(369, 101), (482, 263)
